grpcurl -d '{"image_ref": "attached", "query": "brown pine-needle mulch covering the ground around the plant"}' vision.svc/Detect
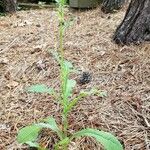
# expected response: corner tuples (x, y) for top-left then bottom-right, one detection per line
(0, 6), (150, 150)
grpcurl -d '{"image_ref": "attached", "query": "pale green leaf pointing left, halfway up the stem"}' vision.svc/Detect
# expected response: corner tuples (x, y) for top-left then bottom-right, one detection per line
(27, 84), (54, 94)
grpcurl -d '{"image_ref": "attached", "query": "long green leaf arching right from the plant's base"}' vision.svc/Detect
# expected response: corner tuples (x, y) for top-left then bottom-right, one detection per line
(72, 128), (123, 150)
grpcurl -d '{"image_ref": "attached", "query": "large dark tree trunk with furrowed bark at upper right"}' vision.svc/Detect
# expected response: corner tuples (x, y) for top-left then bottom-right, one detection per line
(114, 0), (150, 44)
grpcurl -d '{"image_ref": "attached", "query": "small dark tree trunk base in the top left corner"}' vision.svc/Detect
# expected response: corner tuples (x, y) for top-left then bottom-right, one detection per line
(2, 0), (17, 13)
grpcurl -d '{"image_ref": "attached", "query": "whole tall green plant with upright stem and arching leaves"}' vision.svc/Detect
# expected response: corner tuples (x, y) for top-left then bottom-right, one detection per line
(17, 0), (123, 150)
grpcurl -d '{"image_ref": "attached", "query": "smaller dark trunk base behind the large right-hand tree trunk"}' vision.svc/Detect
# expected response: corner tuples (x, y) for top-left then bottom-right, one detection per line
(102, 0), (125, 13)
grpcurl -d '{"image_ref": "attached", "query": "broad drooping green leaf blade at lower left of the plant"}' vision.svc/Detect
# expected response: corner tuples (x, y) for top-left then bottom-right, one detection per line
(17, 125), (42, 143)
